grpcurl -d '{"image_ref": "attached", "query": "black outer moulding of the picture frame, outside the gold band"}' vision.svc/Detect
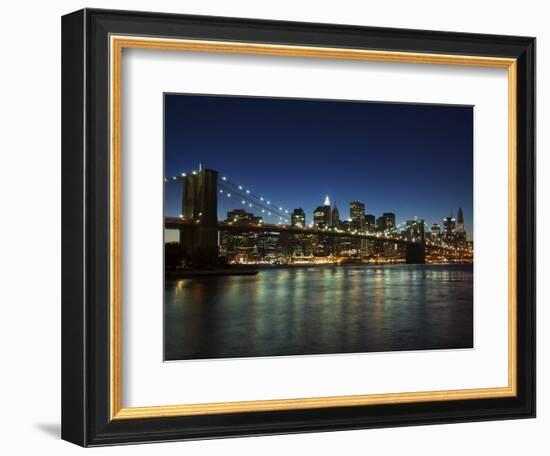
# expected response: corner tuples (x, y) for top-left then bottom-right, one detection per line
(61, 9), (535, 446)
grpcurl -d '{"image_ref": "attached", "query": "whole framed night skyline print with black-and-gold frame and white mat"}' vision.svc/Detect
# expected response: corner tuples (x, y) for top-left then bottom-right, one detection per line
(62, 9), (535, 446)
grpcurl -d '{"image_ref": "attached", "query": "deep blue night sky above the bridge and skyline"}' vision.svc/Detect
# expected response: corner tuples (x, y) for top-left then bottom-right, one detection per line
(165, 94), (473, 240)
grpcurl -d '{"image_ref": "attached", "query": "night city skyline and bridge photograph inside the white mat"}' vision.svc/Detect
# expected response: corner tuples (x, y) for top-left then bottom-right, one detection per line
(164, 93), (474, 361)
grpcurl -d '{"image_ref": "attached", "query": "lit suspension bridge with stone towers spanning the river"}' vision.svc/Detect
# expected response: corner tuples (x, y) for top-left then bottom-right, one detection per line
(164, 167), (468, 268)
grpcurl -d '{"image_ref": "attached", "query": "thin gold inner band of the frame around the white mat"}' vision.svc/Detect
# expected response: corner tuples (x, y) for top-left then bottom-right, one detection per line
(109, 35), (517, 420)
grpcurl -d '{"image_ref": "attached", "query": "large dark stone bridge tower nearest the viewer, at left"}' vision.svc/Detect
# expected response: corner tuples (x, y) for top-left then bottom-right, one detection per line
(180, 169), (218, 268)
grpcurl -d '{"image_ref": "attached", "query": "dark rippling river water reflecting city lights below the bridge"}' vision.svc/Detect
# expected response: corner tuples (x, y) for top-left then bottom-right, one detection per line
(165, 265), (473, 360)
